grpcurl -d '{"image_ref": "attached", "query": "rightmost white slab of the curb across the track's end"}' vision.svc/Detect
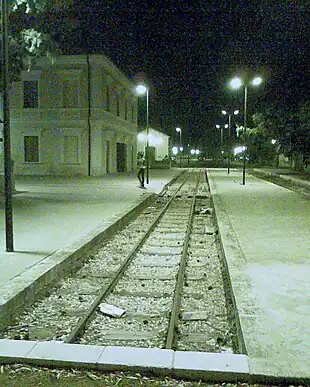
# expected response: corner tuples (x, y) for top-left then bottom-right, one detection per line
(173, 351), (249, 381)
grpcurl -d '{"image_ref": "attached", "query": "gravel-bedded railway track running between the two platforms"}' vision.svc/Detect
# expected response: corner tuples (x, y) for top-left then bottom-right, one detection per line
(1, 171), (234, 352)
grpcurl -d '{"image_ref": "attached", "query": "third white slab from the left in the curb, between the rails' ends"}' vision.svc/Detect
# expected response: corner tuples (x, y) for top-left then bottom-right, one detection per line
(98, 347), (174, 369)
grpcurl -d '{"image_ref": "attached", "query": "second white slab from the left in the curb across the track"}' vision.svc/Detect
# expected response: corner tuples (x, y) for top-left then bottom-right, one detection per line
(27, 341), (104, 367)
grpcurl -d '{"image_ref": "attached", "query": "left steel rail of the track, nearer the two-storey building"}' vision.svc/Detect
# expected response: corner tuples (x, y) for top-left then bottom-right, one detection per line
(64, 174), (190, 344)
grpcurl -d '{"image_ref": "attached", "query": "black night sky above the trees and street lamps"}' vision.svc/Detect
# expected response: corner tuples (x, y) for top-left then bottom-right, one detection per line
(68, 0), (310, 151)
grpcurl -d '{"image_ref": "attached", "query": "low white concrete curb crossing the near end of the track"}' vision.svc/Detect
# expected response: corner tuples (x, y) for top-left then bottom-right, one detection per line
(0, 339), (250, 382)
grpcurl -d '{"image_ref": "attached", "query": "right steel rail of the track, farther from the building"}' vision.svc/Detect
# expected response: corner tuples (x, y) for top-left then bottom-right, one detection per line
(165, 169), (200, 349)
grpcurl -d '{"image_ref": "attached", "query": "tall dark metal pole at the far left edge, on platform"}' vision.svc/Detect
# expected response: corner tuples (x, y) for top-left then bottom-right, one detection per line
(1, 0), (14, 252)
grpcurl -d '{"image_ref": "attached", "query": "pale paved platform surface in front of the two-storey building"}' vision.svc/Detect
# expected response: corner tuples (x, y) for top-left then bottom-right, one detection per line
(0, 168), (180, 287)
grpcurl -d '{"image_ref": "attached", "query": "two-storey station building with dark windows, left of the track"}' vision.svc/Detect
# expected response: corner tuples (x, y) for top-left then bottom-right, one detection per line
(10, 55), (137, 176)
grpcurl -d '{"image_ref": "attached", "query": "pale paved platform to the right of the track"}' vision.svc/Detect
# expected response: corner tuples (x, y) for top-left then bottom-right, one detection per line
(209, 169), (310, 377)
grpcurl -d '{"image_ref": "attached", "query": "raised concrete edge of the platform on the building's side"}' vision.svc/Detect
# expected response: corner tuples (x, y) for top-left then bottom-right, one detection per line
(0, 193), (157, 324)
